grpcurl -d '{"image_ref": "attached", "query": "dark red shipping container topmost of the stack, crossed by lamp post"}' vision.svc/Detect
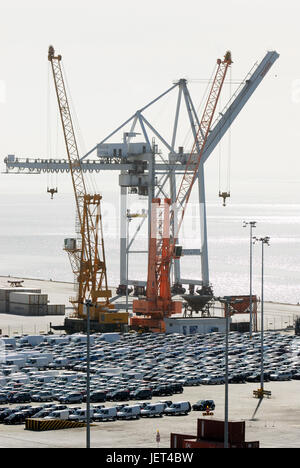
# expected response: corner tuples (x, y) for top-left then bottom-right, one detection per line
(197, 419), (246, 444)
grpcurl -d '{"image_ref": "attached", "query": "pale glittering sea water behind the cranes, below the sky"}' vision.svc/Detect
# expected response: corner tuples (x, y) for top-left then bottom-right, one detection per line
(0, 194), (300, 303)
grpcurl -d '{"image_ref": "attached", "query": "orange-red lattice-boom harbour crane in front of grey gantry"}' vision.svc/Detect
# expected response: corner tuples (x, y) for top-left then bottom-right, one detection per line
(131, 52), (232, 332)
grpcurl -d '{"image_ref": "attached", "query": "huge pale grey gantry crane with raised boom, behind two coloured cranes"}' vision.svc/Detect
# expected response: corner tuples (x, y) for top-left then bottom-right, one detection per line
(4, 50), (279, 307)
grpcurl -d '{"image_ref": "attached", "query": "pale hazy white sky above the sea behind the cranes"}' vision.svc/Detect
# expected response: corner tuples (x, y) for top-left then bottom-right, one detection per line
(0, 0), (300, 203)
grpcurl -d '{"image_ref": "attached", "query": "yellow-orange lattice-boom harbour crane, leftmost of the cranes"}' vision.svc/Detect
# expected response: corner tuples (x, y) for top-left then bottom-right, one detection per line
(48, 46), (122, 323)
